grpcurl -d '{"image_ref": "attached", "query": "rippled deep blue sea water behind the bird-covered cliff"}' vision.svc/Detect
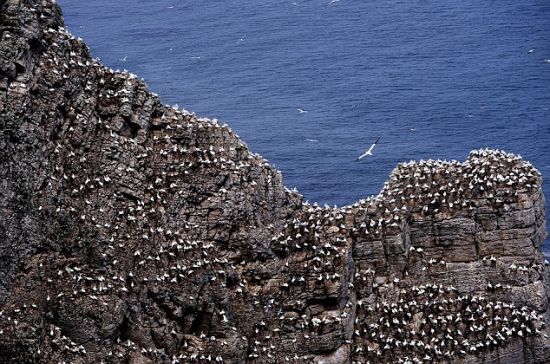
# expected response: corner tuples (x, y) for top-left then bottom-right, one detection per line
(59, 0), (550, 252)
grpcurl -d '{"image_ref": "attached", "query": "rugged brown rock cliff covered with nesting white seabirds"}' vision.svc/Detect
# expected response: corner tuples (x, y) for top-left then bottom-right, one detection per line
(0, 0), (550, 363)
